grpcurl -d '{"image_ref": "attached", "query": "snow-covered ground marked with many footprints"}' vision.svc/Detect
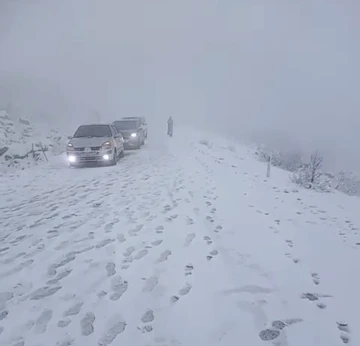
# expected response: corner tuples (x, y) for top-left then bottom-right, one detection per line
(0, 132), (360, 346)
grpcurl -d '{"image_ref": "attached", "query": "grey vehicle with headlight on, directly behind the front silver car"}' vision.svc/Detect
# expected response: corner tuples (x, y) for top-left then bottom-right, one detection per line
(113, 118), (145, 149)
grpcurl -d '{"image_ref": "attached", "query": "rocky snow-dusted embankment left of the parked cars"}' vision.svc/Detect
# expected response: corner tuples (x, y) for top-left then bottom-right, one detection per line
(0, 110), (66, 172)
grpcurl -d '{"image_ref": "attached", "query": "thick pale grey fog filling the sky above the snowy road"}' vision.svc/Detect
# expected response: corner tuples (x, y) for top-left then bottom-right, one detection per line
(0, 0), (360, 170)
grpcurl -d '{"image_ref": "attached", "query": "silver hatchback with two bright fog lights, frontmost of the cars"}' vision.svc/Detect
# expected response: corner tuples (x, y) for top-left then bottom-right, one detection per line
(66, 124), (124, 166)
